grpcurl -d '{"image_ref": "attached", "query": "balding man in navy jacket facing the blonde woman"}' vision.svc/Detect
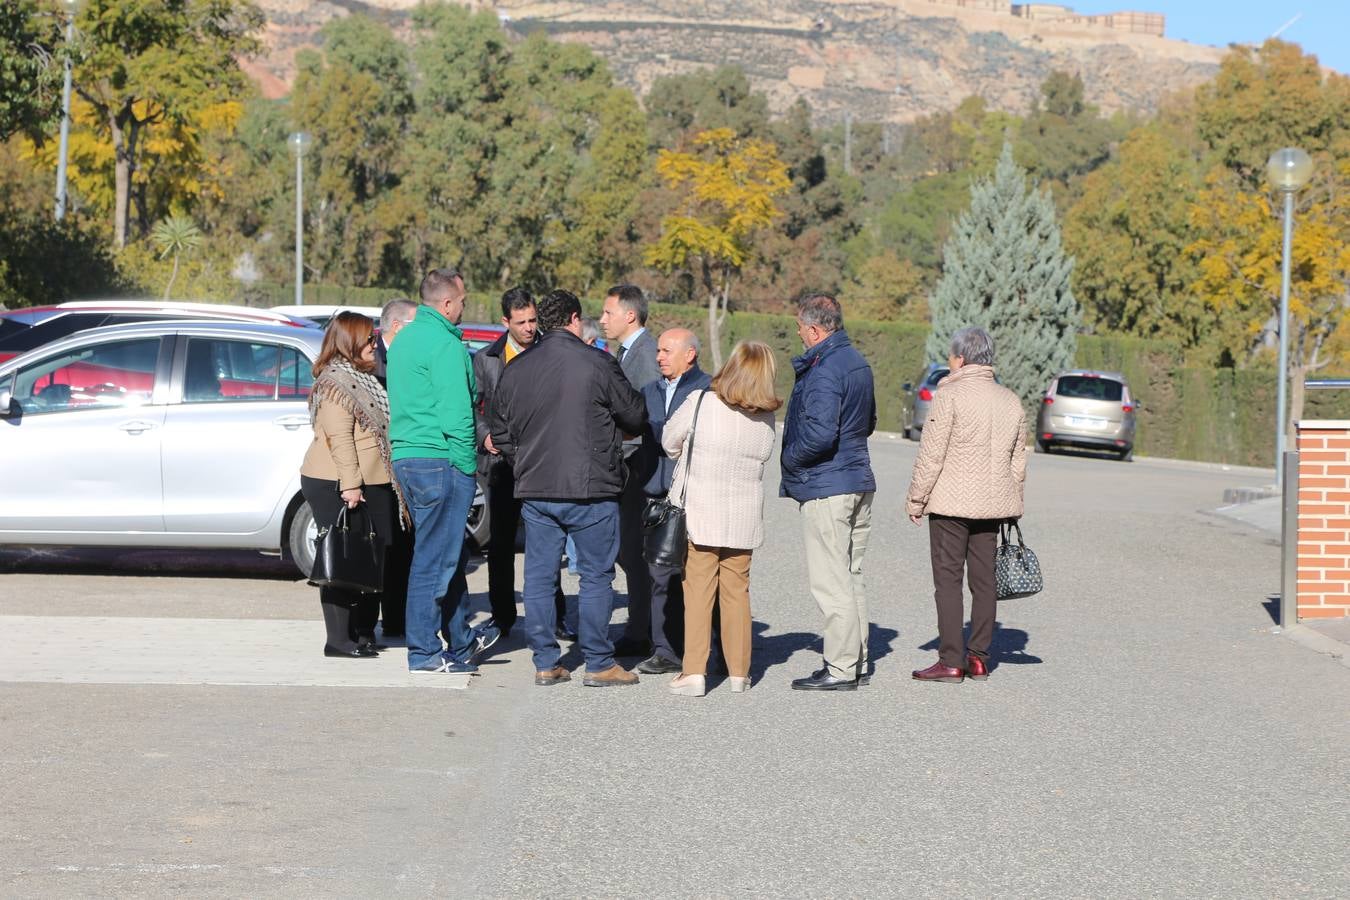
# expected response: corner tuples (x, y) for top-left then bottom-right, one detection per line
(629, 328), (713, 675)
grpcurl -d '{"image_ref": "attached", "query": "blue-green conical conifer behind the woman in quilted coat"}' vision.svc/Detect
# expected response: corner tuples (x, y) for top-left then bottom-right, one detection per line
(927, 143), (1079, 407)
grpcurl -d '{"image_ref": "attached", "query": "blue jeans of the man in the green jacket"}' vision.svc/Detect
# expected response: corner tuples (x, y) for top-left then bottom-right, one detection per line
(394, 459), (474, 669)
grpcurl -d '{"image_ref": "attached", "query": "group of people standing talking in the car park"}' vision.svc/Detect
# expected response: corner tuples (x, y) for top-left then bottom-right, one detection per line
(301, 269), (1025, 696)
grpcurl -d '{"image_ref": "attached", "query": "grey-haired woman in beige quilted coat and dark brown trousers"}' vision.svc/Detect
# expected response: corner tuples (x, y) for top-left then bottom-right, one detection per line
(907, 328), (1026, 684)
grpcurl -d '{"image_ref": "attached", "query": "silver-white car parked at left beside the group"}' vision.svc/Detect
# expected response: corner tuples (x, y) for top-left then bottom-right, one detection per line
(0, 321), (486, 576)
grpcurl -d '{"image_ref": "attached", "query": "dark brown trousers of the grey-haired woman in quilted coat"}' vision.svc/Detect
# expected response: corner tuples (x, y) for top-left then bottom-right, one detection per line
(929, 515), (1004, 669)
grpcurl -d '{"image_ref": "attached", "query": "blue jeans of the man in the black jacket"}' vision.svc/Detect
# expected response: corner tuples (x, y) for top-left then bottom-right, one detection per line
(521, 498), (618, 672)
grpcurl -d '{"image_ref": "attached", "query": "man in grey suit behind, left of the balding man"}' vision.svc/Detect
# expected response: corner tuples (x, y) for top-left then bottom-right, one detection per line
(599, 285), (662, 656)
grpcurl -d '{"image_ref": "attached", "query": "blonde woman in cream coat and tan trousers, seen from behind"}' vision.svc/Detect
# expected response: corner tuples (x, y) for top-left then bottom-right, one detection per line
(662, 340), (783, 696)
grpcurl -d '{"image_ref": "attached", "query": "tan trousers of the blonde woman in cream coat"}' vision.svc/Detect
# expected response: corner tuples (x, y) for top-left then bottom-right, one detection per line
(682, 542), (751, 679)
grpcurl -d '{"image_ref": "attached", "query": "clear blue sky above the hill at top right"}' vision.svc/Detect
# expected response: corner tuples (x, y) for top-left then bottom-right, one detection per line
(1056, 0), (1350, 74)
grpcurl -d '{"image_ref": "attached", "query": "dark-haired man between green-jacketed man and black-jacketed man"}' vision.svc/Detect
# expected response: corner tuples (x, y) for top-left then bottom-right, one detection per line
(474, 287), (576, 641)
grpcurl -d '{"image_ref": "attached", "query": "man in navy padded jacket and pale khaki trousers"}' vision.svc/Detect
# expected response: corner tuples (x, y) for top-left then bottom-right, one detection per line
(779, 294), (876, 691)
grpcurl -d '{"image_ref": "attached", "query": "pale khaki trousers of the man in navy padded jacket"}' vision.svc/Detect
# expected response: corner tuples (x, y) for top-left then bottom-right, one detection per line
(802, 491), (872, 679)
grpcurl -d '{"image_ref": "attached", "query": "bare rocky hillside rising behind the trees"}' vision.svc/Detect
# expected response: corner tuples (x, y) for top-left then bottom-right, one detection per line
(248, 0), (1223, 121)
